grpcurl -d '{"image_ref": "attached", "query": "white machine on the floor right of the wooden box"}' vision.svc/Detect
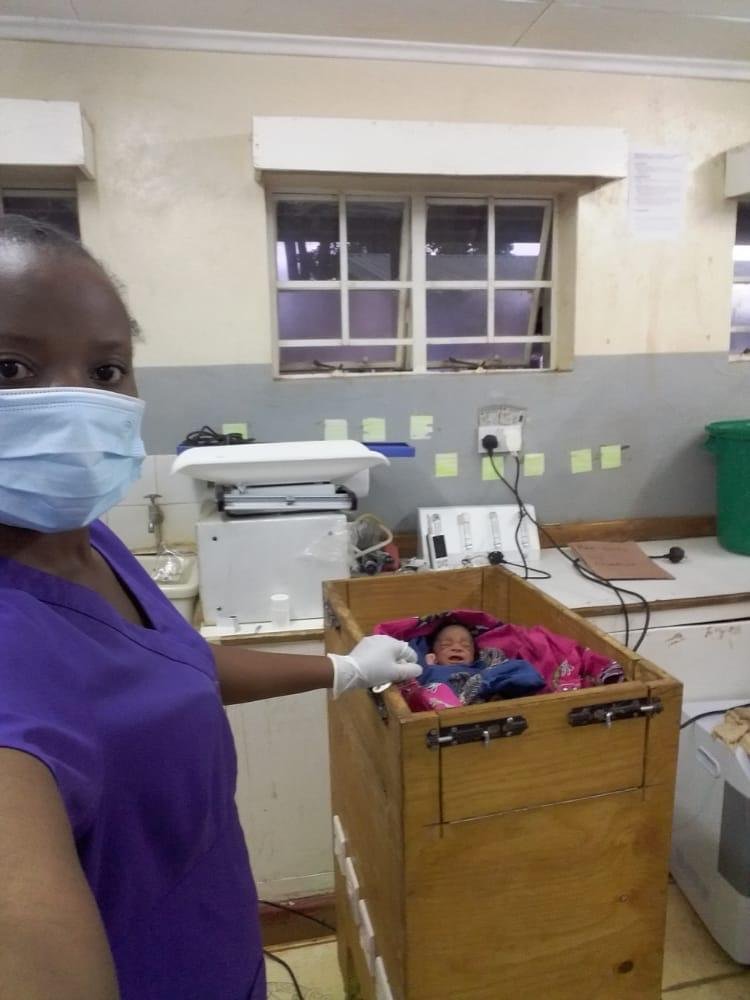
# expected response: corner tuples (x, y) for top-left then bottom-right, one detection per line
(670, 698), (750, 964)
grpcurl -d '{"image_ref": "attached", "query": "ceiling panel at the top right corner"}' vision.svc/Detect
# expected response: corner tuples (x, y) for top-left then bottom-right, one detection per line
(523, 5), (750, 60)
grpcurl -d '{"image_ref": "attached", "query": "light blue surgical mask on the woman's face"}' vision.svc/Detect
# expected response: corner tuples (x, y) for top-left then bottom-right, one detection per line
(0, 389), (145, 532)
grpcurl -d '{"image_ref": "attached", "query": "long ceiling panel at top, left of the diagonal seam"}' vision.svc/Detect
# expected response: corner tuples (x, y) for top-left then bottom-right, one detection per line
(67, 0), (548, 45)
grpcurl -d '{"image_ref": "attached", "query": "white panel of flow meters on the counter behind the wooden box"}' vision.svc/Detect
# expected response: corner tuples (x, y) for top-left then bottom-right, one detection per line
(418, 504), (539, 569)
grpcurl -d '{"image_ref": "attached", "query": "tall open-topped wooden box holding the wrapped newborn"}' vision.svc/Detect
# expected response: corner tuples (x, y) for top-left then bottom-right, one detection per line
(326, 567), (682, 1000)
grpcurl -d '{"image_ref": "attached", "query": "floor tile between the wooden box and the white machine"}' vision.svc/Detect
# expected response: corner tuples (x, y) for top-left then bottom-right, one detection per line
(662, 884), (750, 984)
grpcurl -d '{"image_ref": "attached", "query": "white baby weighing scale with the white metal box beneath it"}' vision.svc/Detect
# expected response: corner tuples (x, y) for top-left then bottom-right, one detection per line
(172, 441), (389, 626)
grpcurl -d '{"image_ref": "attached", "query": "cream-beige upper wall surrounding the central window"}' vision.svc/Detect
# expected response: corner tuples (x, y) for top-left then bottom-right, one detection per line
(0, 42), (750, 365)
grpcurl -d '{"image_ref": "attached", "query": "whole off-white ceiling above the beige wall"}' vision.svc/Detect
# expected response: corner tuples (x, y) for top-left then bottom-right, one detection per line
(0, 0), (750, 64)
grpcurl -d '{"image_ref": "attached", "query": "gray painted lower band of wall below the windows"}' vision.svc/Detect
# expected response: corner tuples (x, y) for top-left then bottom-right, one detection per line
(138, 354), (750, 531)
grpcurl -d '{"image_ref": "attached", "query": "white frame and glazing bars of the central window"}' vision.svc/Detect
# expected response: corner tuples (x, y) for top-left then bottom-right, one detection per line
(266, 185), (560, 379)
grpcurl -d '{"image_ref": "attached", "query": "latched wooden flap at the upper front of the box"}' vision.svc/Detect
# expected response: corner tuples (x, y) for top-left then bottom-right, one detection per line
(440, 682), (648, 822)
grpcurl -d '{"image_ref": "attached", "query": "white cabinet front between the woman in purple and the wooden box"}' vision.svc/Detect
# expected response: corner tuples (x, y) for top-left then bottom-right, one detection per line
(220, 640), (333, 900)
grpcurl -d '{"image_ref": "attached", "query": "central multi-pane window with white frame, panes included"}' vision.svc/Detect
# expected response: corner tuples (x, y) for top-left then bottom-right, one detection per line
(271, 194), (554, 375)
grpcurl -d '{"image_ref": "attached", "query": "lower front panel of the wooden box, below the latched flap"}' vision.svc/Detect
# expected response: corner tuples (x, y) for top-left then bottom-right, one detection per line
(406, 788), (669, 1000)
